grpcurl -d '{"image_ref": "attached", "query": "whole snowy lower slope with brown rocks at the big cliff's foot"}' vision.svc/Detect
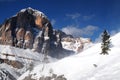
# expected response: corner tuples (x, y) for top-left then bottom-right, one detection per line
(0, 45), (56, 80)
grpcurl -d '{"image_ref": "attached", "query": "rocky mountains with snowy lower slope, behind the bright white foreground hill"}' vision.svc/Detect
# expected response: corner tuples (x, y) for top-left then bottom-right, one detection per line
(0, 7), (92, 80)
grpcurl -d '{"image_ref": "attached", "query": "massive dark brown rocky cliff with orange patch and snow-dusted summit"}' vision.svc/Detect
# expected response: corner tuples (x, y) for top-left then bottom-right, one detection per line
(0, 8), (70, 56)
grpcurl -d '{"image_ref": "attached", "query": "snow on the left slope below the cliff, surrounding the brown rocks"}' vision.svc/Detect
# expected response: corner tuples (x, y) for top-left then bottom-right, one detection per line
(0, 45), (56, 80)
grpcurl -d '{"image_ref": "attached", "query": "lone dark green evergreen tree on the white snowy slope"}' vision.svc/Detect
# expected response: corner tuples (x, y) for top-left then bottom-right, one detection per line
(101, 30), (110, 55)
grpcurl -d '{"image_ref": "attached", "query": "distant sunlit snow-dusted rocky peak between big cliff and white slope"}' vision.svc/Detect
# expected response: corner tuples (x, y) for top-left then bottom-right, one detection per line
(62, 37), (92, 53)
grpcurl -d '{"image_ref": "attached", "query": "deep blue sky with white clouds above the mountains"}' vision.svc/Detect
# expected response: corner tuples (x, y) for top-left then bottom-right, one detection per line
(0, 0), (120, 40)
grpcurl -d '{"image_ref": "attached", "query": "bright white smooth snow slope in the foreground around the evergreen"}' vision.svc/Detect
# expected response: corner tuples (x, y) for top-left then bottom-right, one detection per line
(18, 33), (120, 80)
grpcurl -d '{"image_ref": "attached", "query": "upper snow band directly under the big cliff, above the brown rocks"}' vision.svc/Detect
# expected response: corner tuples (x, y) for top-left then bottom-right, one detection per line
(0, 45), (56, 62)
